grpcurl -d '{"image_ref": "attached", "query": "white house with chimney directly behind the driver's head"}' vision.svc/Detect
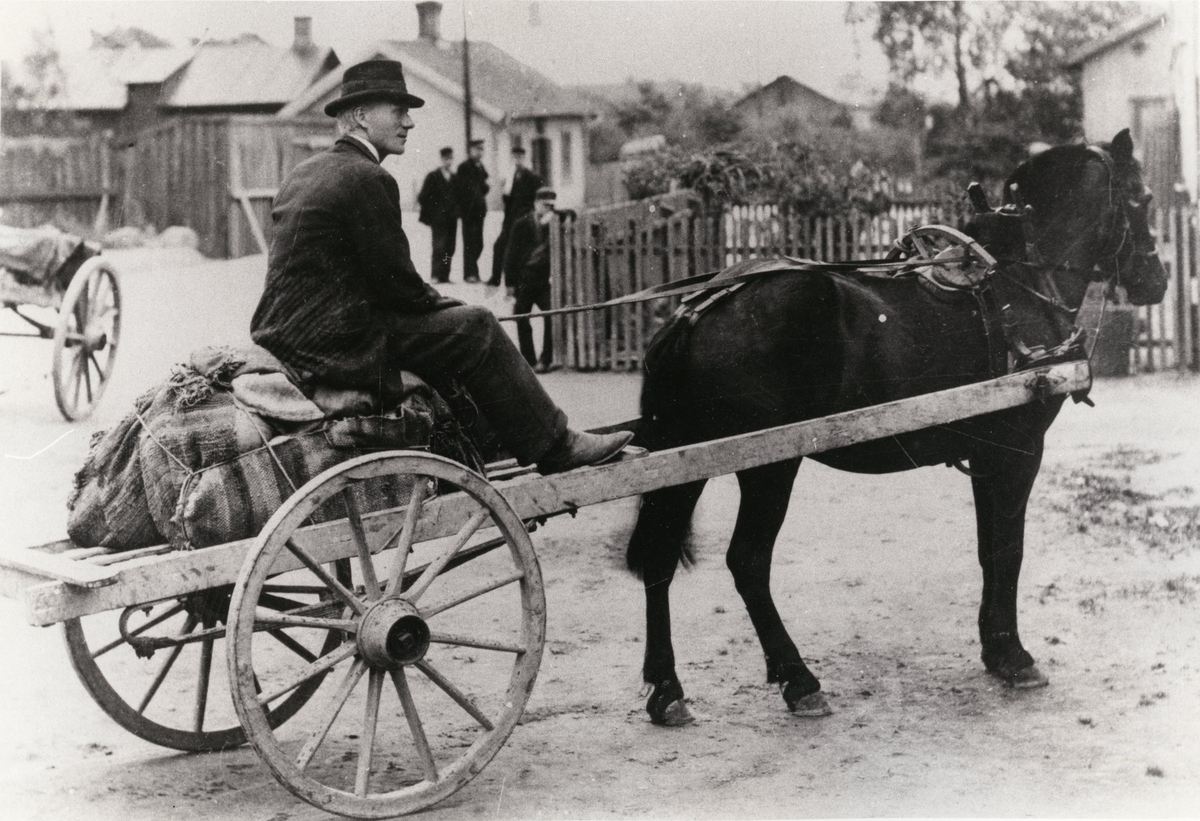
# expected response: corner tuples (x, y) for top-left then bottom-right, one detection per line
(277, 2), (593, 211)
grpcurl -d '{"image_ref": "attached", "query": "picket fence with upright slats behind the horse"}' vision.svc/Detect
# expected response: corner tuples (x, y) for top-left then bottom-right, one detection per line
(551, 194), (1200, 371)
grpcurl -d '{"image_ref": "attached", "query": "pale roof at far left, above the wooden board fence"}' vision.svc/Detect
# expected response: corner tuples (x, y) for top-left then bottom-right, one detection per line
(5, 47), (192, 112)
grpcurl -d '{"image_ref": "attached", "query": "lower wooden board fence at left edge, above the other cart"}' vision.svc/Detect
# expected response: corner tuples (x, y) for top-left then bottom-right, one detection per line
(0, 133), (122, 235)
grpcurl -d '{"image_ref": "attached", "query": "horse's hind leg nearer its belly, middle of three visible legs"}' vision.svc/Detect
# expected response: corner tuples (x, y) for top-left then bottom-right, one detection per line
(725, 459), (830, 715)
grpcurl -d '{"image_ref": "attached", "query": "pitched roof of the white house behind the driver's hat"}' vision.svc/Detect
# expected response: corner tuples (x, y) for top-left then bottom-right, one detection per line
(278, 40), (596, 122)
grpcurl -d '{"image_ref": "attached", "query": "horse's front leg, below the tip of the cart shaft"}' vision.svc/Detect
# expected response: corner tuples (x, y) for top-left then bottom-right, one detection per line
(971, 441), (1050, 688)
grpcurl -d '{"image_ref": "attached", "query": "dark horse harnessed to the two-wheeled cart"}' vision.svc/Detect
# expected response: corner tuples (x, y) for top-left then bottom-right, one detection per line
(628, 131), (1166, 724)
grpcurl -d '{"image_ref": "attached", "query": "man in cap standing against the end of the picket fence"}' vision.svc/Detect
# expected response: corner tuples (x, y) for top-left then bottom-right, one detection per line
(504, 187), (556, 373)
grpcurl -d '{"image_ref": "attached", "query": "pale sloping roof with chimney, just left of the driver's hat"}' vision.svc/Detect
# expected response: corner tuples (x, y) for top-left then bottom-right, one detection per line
(162, 37), (337, 108)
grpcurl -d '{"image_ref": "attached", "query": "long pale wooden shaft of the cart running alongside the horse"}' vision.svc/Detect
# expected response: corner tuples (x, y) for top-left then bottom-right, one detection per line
(16, 361), (1091, 625)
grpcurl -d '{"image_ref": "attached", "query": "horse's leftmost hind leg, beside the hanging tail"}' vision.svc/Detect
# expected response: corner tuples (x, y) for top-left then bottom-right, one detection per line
(628, 480), (704, 726)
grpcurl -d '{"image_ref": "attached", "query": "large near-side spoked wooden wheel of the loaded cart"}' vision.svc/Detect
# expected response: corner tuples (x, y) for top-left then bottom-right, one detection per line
(228, 451), (546, 819)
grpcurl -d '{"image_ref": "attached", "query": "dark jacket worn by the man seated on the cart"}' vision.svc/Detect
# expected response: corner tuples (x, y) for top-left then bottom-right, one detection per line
(251, 137), (452, 377)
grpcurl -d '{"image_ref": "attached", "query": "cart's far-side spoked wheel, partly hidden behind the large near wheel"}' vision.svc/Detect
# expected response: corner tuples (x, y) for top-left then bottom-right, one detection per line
(64, 562), (349, 753)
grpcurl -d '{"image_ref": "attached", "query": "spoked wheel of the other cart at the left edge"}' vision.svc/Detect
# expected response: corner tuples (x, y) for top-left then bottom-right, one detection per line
(53, 257), (121, 421)
